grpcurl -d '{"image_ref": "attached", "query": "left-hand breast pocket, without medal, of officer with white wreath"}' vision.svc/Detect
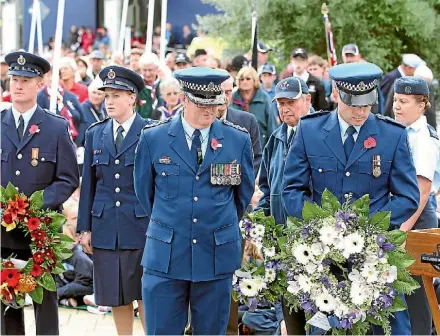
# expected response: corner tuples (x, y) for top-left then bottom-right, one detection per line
(308, 156), (338, 193)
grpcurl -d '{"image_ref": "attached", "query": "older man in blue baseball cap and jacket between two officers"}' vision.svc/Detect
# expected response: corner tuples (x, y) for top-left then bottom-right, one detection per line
(255, 77), (311, 335)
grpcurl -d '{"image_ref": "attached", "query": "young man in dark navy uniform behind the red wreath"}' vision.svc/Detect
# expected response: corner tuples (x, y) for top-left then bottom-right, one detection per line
(1, 52), (79, 335)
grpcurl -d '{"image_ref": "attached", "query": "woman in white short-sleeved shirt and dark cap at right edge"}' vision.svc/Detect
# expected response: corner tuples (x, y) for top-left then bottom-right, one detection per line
(393, 76), (440, 335)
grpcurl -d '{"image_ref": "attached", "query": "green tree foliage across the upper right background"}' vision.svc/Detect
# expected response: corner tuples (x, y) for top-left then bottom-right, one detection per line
(198, 0), (440, 74)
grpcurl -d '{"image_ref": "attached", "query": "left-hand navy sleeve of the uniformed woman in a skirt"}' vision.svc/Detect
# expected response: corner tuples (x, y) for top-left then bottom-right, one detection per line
(76, 130), (96, 232)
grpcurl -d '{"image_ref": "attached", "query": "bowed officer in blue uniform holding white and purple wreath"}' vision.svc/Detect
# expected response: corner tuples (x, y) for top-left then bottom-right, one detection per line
(283, 62), (419, 335)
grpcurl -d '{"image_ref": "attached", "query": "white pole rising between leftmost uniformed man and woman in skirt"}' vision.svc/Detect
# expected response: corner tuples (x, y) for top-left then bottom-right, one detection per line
(50, 0), (65, 113)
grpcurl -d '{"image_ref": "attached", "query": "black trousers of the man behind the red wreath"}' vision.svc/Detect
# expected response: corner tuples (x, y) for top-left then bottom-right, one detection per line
(0, 248), (59, 335)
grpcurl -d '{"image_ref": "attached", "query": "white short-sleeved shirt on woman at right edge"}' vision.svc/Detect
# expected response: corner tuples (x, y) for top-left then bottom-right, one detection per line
(407, 116), (440, 193)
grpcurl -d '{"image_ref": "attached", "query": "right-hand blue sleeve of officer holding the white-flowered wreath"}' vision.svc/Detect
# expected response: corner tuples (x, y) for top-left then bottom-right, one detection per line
(380, 131), (420, 226)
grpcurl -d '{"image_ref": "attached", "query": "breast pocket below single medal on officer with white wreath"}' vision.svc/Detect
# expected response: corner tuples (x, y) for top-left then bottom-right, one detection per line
(357, 160), (391, 199)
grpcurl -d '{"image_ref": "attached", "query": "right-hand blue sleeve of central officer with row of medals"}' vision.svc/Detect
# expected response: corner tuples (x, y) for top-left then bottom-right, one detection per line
(234, 137), (255, 220)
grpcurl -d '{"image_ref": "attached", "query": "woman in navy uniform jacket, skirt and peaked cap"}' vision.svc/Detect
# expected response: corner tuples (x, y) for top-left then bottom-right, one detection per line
(77, 66), (148, 335)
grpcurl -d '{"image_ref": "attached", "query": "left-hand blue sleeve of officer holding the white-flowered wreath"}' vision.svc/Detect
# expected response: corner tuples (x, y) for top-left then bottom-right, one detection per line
(283, 122), (313, 218)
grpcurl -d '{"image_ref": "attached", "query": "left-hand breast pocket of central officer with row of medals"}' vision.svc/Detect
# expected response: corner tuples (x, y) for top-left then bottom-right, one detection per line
(154, 162), (180, 199)
